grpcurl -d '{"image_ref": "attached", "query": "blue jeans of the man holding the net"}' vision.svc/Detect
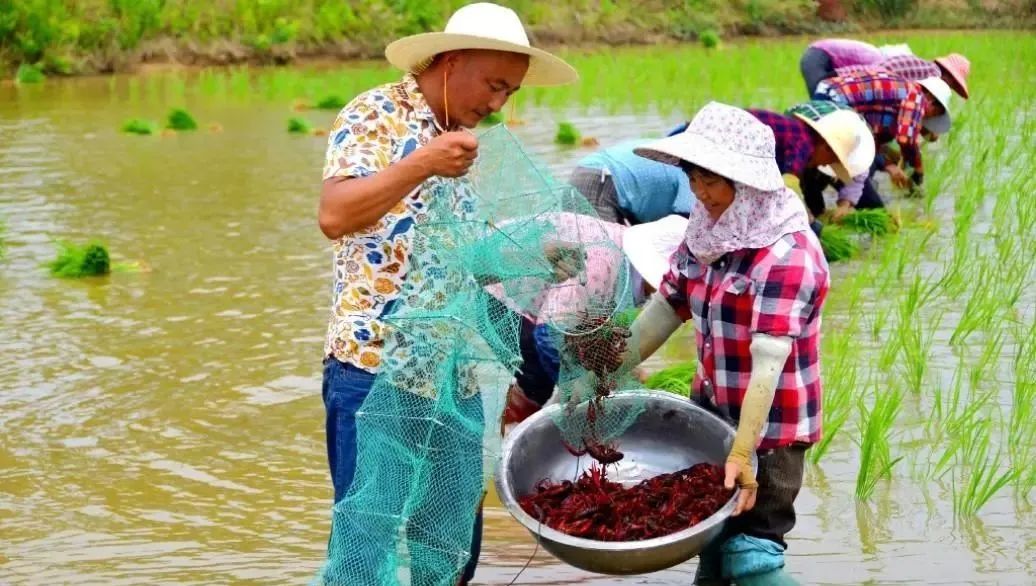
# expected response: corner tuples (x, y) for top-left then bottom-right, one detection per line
(322, 358), (482, 585)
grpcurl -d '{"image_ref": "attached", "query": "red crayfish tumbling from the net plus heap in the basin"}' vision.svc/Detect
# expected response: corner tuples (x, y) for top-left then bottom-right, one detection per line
(518, 319), (733, 541)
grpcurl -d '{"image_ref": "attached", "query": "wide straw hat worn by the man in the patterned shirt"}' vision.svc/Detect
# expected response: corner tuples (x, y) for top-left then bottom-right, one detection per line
(385, 2), (579, 86)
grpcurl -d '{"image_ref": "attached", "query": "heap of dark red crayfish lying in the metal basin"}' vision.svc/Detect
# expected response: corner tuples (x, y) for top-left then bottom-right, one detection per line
(518, 463), (733, 541)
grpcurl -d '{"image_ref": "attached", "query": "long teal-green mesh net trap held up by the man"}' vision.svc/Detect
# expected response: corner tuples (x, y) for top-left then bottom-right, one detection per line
(318, 126), (639, 586)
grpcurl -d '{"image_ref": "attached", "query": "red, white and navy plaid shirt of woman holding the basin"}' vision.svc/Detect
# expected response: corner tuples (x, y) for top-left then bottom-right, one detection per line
(659, 231), (830, 450)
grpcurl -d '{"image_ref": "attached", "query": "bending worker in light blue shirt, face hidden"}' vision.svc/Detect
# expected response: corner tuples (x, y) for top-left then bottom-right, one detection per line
(569, 139), (692, 226)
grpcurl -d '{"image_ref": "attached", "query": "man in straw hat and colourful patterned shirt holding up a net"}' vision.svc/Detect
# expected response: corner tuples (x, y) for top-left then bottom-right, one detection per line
(319, 2), (578, 586)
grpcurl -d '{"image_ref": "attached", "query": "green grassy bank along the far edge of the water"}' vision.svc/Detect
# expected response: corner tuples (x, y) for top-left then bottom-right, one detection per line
(0, 0), (1036, 78)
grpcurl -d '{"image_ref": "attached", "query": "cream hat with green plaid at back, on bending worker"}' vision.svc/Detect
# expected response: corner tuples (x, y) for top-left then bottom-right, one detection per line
(787, 100), (874, 183)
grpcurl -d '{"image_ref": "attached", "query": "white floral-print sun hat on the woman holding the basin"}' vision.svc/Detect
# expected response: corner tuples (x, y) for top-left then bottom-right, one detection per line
(633, 101), (784, 192)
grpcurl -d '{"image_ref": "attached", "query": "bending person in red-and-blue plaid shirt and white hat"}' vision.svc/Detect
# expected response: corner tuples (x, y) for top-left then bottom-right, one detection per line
(803, 72), (952, 215)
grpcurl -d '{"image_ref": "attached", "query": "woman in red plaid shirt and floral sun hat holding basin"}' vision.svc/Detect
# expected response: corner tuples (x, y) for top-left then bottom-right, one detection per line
(617, 102), (830, 586)
